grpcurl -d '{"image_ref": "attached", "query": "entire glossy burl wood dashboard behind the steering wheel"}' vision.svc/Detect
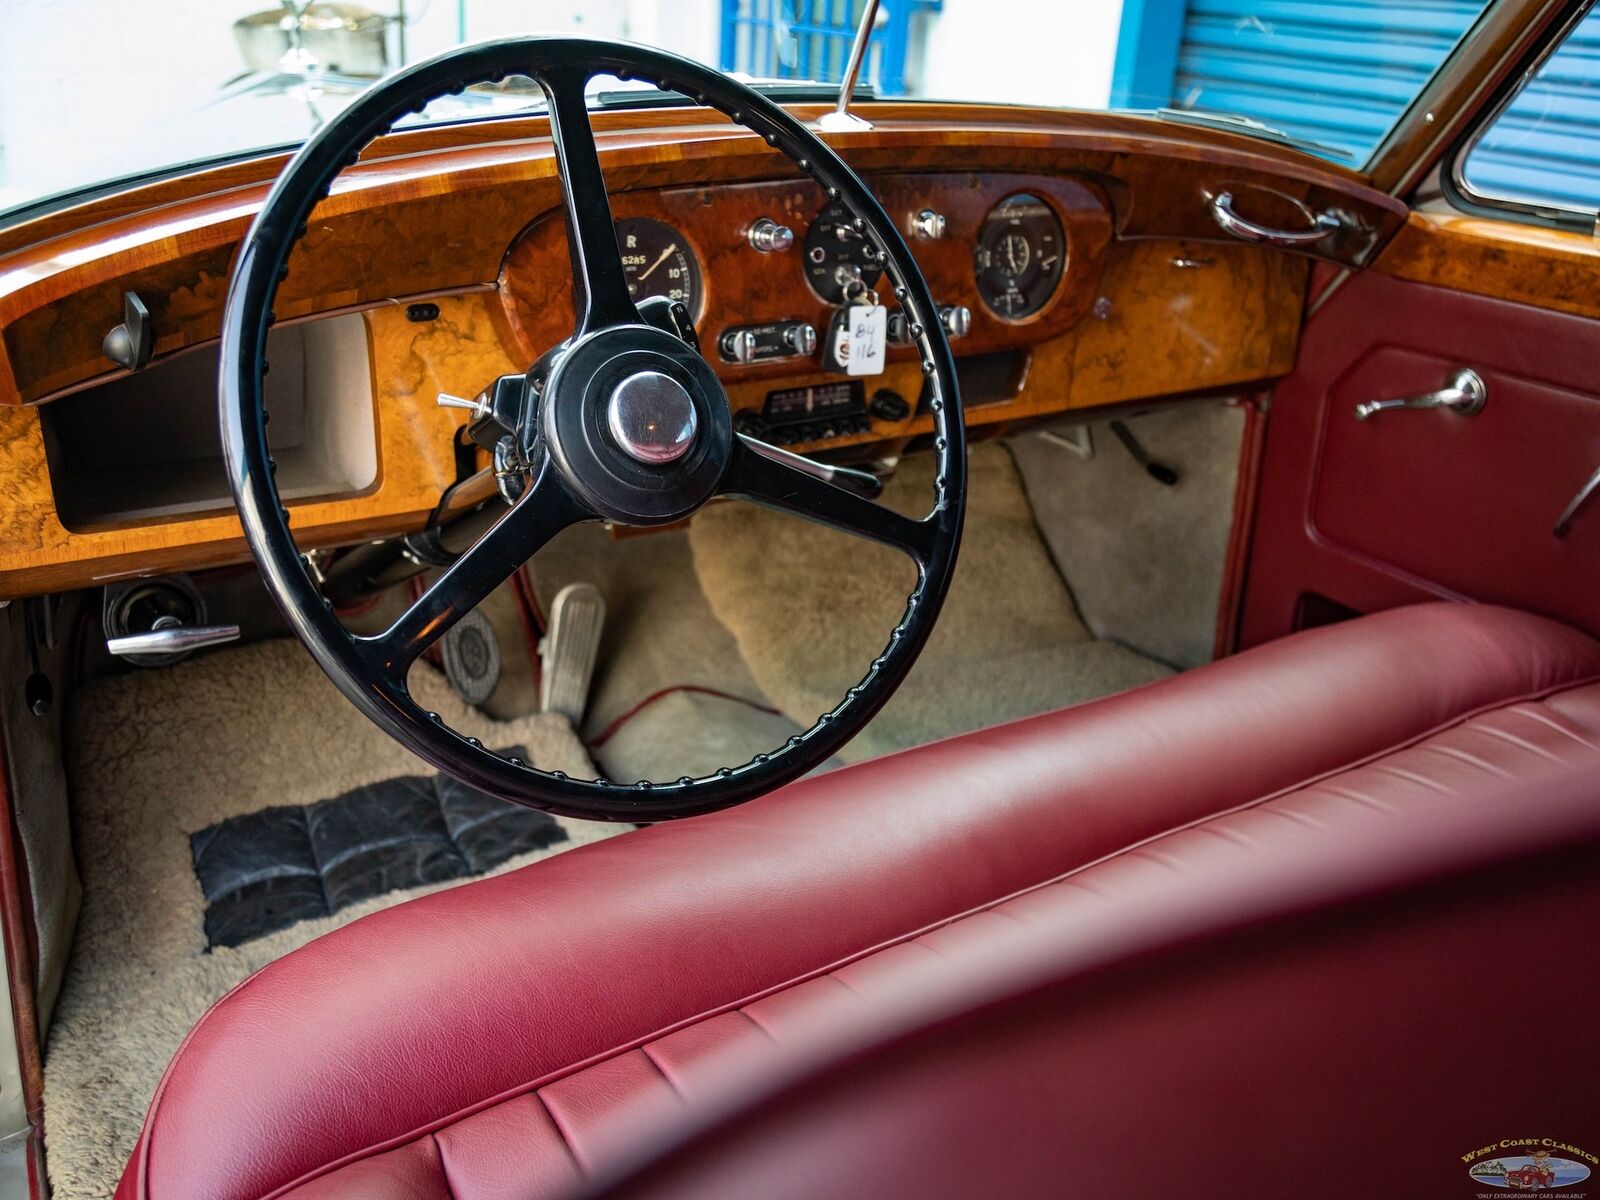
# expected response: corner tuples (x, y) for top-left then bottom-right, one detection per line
(0, 104), (1406, 597)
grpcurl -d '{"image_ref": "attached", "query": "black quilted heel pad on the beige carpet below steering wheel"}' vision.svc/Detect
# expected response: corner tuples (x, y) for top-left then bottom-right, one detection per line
(189, 747), (566, 947)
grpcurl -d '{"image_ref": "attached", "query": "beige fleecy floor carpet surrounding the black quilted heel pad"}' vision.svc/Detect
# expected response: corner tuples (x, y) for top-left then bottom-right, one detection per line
(45, 642), (621, 1200)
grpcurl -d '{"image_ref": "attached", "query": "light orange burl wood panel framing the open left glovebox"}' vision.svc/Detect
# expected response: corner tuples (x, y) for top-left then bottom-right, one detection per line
(0, 293), (518, 598)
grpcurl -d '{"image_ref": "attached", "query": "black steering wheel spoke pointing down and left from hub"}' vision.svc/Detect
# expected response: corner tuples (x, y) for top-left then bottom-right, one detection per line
(355, 462), (594, 685)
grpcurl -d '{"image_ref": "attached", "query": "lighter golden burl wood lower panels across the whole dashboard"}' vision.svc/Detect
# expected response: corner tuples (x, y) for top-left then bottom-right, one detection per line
(0, 240), (1307, 598)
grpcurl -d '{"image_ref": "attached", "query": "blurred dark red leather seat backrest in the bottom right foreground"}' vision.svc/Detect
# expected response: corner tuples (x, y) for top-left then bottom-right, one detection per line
(589, 686), (1600, 1200)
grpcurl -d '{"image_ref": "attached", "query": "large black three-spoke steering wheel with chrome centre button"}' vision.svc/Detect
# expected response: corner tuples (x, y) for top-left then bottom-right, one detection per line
(219, 37), (966, 821)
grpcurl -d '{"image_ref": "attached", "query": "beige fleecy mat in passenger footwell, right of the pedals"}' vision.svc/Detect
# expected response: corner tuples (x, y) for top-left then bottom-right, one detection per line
(690, 443), (1171, 762)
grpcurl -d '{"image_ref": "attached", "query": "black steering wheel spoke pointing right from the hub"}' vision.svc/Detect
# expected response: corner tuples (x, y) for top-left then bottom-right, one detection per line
(722, 434), (938, 566)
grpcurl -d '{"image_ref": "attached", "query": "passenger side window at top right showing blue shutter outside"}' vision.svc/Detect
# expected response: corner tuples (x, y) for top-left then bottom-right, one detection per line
(1451, 8), (1600, 227)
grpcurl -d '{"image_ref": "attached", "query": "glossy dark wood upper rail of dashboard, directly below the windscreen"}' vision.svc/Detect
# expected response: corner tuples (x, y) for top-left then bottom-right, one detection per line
(0, 104), (1405, 403)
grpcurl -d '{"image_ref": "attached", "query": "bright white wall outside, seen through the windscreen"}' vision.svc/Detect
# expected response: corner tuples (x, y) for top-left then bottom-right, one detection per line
(0, 0), (1122, 208)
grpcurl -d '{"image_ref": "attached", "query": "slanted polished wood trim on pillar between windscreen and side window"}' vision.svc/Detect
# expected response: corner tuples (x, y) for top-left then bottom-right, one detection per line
(1366, 0), (1584, 195)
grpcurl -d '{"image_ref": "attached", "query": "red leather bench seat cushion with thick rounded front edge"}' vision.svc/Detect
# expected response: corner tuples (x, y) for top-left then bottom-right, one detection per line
(118, 605), (1600, 1200)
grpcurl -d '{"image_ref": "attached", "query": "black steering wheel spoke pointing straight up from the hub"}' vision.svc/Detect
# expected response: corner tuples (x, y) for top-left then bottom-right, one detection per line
(539, 67), (640, 336)
